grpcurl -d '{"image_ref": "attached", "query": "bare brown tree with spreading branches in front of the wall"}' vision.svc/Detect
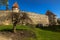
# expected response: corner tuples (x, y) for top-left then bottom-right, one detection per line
(11, 12), (32, 33)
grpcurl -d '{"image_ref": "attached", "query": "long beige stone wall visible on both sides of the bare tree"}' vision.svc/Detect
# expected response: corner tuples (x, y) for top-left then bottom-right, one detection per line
(0, 11), (49, 25)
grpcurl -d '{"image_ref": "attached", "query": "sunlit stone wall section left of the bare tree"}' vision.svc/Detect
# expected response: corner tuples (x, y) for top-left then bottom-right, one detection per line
(0, 11), (11, 25)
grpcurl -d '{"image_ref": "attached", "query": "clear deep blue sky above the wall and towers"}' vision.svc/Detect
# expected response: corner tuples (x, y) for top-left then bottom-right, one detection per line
(0, 0), (60, 18)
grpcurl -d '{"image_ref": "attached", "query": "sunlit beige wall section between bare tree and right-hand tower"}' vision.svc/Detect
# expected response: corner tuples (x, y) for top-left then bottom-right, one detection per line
(27, 12), (49, 25)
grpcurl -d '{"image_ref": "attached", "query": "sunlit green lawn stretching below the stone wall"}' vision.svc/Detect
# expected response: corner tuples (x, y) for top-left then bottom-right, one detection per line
(0, 25), (60, 40)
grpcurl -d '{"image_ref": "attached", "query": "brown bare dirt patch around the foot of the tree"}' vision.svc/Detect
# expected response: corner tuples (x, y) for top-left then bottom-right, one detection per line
(0, 30), (36, 40)
